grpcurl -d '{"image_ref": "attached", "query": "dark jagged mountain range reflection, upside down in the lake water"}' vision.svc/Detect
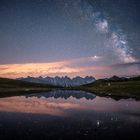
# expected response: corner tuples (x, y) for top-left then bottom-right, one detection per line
(26, 90), (96, 100)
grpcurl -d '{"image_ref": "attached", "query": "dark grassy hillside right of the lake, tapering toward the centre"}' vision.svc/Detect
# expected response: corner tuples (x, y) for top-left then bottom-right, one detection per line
(79, 76), (140, 97)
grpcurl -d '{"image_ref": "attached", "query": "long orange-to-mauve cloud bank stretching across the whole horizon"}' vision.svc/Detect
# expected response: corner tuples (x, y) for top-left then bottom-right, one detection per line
(0, 55), (140, 78)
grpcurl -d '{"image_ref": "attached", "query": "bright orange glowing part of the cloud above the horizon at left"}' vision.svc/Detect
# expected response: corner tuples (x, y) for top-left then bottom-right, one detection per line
(0, 61), (86, 78)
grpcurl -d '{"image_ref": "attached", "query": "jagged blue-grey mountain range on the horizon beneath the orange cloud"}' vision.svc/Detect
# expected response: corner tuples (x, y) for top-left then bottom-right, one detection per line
(18, 76), (95, 87)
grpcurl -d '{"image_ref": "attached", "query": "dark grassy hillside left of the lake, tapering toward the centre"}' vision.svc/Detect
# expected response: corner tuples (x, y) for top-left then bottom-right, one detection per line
(0, 78), (57, 97)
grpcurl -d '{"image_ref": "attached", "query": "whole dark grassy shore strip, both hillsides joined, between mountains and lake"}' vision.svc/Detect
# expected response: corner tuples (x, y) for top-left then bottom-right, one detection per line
(0, 76), (140, 99)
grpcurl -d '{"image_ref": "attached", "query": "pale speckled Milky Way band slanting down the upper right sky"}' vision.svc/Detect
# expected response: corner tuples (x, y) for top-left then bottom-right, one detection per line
(63, 0), (137, 63)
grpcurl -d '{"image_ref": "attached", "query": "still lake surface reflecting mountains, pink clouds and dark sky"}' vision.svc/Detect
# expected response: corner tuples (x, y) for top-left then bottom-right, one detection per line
(0, 91), (140, 140)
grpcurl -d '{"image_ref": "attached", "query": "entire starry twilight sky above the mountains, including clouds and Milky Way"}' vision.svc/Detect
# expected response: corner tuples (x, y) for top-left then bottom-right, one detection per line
(0, 0), (140, 78)
